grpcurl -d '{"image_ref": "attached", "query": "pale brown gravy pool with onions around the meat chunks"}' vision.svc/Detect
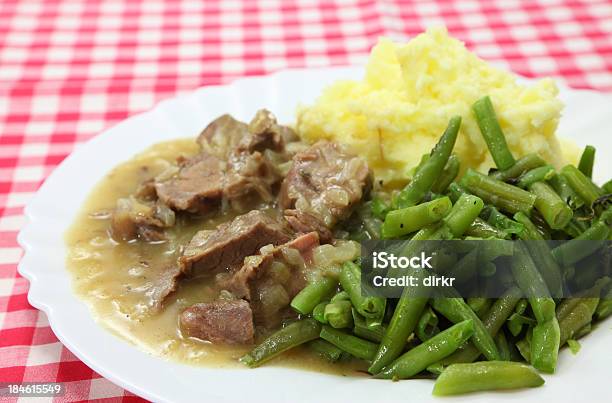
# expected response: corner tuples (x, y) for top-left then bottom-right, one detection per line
(66, 139), (365, 375)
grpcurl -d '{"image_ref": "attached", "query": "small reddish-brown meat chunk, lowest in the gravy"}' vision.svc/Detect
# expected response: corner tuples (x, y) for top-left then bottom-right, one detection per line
(180, 299), (254, 344)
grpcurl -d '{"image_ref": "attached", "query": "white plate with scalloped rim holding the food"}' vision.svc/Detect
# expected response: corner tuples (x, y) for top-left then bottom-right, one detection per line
(18, 68), (612, 402)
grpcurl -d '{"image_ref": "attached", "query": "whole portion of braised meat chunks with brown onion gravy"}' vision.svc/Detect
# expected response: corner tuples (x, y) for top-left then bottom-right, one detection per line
(68, 110), (371, 370)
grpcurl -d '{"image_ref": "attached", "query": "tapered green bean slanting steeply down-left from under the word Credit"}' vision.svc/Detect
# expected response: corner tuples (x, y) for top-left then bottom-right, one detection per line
(368, 270), (428, 374)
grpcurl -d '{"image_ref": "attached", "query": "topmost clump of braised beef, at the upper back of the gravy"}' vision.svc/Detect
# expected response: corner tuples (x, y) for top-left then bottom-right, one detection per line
(156, 110), (295, 212)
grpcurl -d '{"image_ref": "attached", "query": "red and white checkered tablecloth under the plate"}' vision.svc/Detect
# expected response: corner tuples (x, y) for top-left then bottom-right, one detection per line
(0, 0), (612, 401)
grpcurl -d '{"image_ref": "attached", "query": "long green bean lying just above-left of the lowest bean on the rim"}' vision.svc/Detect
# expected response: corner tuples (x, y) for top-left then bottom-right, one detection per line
(374, 320), (474, 379)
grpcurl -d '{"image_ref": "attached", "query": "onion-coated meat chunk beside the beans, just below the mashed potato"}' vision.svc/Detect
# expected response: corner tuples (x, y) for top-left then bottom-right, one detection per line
(279, 141), (371, 234)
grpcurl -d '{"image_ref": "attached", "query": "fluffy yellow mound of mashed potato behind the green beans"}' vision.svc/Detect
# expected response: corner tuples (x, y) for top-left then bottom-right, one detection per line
(297, 28), (563, 186)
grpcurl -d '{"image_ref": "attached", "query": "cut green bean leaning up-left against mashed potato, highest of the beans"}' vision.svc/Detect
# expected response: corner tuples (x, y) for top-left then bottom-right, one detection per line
(472, 95), (516, 170)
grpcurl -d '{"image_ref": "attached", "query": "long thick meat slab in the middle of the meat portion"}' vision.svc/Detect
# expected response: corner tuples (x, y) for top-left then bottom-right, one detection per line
(179, 210), (292, 275)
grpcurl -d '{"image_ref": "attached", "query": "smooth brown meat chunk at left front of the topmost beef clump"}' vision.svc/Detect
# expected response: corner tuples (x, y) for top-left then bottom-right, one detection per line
(155, 153), (226, 213)
